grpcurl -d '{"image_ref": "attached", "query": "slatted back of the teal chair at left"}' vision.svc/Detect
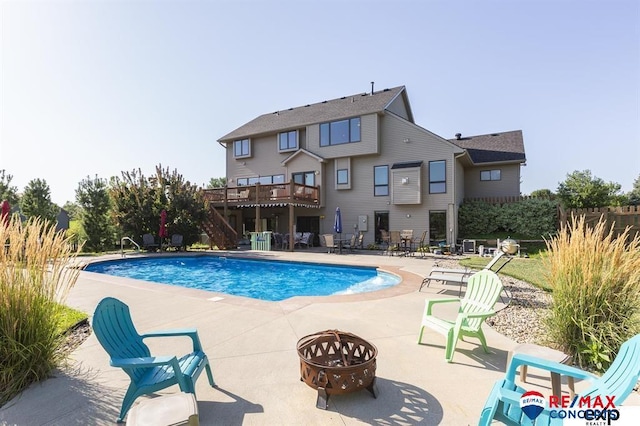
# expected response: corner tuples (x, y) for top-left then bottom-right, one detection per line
(92, 297), (151, 381)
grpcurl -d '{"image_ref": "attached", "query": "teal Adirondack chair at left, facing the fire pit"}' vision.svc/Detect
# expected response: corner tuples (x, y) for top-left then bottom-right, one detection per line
(92, 297), (215, 422)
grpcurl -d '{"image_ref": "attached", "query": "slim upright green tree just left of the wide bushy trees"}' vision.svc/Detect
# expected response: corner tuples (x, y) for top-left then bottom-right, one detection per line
(76, 176), (114, 251)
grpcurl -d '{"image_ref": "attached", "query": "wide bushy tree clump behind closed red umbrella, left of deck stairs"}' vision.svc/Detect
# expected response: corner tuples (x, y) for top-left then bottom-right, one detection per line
(109, 165), (206, 245)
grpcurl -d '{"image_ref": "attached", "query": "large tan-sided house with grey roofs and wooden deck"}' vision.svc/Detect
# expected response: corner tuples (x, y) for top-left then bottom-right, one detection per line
(206, 86), (526, 250)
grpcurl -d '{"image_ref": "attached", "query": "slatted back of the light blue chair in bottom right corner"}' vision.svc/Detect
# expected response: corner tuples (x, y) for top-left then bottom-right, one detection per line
(580, 334), (640, 405)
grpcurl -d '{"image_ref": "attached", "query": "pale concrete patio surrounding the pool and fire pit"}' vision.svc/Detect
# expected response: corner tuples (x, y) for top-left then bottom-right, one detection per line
(0, 250), (576, 426)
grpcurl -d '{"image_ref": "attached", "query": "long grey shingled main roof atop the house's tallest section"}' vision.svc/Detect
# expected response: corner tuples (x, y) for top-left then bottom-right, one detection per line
(218, 86), (411, 142)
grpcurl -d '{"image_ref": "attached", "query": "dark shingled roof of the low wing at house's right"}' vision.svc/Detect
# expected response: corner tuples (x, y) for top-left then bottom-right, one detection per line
(449, 130), (527, 164)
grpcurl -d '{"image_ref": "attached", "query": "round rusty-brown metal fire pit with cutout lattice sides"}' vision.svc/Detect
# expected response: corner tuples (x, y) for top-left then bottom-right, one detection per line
(297, 330), (378, 410)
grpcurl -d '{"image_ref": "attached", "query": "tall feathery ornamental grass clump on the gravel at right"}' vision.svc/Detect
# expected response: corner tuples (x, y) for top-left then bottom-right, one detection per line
(543, 216), (640, 372)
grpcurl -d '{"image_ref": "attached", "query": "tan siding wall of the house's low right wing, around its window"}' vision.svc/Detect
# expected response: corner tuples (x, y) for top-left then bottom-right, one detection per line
(464, 164), (520, 198)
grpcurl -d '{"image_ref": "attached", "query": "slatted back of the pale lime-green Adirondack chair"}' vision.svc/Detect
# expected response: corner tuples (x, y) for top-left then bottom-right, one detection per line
(460, 269), (502, 330)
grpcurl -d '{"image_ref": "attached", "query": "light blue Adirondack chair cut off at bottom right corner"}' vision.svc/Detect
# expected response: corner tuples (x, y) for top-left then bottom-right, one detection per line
(478, 334), (640, 426)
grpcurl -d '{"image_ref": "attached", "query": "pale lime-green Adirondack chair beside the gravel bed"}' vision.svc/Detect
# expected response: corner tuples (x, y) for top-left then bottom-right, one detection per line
(418, 269), (502, 362)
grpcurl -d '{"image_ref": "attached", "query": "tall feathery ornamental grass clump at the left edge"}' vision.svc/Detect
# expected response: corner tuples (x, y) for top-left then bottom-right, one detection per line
(0, 216), (79, 406)
